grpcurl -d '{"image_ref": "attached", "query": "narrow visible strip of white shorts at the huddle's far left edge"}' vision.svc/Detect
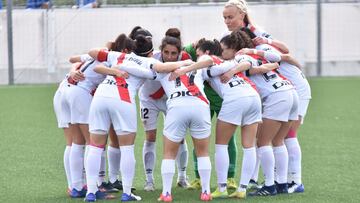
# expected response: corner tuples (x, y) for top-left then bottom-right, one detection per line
(53, 80), (69, 128)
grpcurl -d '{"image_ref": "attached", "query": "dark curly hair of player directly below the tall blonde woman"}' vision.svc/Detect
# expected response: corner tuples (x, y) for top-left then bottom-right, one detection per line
(220, 30), (255, 51)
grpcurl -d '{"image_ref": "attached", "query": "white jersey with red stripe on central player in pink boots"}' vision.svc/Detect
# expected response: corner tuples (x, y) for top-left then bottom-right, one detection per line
(156, 67), (209, 109)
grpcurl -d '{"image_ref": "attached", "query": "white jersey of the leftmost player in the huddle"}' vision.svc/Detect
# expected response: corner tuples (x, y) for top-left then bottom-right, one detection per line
(76, 58), (106, 92)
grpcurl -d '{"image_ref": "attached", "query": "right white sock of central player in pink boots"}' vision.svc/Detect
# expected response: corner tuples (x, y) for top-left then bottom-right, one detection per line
(197, 156), (211, 194)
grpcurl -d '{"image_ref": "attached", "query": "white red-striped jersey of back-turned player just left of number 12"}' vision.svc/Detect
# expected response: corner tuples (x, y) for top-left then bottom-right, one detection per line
(94, 51), (156, 103)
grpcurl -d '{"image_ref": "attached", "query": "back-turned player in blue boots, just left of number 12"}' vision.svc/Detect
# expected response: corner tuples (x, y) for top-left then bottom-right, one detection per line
(85, 34), (194, 201)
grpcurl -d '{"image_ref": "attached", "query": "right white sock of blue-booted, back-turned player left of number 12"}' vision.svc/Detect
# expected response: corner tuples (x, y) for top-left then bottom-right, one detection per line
(120, 145), (136, 195)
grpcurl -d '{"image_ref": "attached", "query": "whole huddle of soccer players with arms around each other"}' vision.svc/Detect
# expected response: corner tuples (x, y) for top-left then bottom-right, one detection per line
(54, 0), (311, 202)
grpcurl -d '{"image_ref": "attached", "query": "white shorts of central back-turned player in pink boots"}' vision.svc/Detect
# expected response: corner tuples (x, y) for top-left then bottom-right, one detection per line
(163, 104), (211, 142)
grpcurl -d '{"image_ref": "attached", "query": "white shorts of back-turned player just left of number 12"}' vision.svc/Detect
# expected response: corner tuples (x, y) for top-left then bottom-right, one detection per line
(89, 97), (137, 135)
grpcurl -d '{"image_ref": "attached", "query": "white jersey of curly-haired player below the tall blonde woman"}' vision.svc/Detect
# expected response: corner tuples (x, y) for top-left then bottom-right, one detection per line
(235, 55), (294, 99)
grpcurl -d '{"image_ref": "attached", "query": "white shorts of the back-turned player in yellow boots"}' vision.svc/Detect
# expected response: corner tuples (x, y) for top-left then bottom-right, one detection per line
(218, 96), (261, 126)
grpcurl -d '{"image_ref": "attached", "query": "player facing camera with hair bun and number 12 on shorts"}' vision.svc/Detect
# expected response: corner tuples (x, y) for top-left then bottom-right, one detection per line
(139, 28), (190, 191)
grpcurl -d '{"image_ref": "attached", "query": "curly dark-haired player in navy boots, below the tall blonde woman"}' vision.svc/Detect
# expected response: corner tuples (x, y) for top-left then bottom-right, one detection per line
(221, 30), (298, 196)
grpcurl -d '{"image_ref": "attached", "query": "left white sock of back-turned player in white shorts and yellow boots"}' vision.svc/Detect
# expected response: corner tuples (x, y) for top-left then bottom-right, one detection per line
(214, 144), (229, 192)
